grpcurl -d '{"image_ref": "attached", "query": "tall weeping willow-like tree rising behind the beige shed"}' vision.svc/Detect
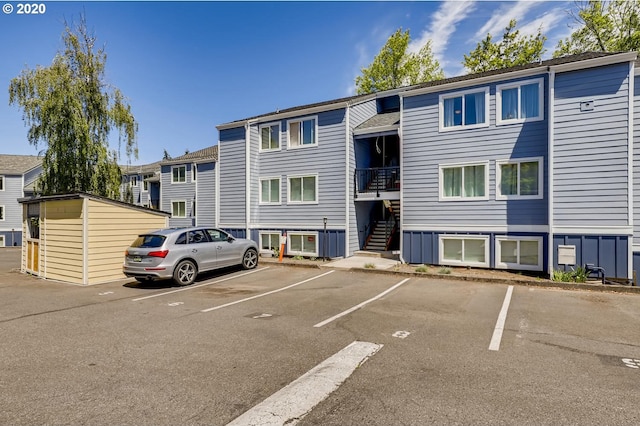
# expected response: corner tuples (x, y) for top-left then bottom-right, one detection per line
(9, 18), (138, 198)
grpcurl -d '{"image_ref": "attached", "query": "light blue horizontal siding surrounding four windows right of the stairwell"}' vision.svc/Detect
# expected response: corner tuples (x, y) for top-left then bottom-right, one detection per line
(402, 76), (548, 230)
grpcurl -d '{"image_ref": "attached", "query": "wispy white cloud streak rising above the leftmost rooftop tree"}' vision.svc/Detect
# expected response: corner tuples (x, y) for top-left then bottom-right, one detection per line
(408, 1), (476, 66)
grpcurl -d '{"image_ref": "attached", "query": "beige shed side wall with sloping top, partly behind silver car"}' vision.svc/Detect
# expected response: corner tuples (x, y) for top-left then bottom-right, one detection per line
(87, 200), (167, 284)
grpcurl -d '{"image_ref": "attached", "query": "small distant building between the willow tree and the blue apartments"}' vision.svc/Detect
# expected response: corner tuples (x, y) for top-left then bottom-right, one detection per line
(120, 161), (160, 210)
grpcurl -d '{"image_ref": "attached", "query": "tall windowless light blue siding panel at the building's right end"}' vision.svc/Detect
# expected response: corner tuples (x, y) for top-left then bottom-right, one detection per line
(553, 64), (629, 226)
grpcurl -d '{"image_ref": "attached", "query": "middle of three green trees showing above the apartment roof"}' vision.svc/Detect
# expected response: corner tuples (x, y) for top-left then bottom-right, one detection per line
(462, 19), (547, 73)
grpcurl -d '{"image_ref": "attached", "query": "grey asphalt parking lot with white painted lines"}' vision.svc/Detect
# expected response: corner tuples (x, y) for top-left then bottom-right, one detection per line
(0, 246), (640, 425)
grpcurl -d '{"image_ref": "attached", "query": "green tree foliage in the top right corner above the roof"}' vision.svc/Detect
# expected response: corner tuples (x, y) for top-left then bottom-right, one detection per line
(553, 0), (640, 58)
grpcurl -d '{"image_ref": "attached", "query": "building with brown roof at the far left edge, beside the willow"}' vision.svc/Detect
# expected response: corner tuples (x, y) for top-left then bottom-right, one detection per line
(0, 154), (42, 247)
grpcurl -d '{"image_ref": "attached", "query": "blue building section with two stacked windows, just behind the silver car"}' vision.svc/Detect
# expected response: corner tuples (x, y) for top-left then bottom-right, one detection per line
(160, 146), (218, 227)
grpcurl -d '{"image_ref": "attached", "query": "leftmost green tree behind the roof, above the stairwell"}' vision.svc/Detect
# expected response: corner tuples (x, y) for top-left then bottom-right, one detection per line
(356, 28), (444, 95)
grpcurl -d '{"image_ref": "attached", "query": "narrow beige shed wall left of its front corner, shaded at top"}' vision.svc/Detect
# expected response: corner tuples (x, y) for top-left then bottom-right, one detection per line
(40, 199), (84, 284)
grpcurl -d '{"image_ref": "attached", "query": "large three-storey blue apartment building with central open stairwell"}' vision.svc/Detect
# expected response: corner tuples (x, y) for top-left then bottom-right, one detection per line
(216, 53), (640, 278)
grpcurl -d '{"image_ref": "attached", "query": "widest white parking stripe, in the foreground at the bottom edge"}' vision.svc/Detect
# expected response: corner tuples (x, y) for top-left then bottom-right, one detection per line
(228, 341), (382, 426)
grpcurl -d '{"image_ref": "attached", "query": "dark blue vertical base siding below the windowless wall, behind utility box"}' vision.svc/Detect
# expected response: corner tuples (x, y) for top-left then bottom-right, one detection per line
(553, 235), (629, 278)
